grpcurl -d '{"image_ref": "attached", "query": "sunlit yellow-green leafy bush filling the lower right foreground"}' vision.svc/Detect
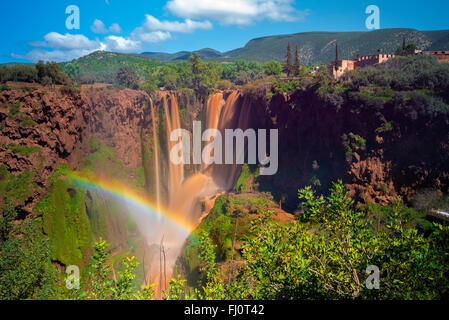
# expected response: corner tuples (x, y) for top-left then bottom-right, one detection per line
(198, 182), (449, 300)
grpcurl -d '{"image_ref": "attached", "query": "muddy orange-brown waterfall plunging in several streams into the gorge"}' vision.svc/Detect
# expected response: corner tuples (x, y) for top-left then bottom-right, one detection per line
(148, 91), (249, 293)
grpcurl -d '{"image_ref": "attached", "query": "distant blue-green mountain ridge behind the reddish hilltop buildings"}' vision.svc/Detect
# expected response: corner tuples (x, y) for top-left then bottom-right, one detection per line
(138, 29), (449, 64)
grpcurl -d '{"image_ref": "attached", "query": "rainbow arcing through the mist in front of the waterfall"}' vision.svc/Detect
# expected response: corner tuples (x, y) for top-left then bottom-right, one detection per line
(69, 172), (194, 235)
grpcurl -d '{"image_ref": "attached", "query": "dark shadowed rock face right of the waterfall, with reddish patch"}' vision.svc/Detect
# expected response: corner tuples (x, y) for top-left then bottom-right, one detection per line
(245, 90), (449, 211)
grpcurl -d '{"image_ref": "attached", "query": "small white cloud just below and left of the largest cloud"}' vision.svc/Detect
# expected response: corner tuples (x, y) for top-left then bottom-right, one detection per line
(144, 14), (212, 33)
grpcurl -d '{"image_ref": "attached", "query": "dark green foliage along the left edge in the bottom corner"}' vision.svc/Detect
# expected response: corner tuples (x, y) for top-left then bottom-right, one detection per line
(0, 165), (58, 300)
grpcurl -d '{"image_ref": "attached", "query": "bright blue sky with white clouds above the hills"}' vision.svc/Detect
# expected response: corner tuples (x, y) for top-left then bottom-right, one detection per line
(0, 0), (449, 63)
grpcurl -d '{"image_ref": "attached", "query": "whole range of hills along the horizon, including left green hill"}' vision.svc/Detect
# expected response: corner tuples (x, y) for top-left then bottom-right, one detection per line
(60, 29), (449, 87)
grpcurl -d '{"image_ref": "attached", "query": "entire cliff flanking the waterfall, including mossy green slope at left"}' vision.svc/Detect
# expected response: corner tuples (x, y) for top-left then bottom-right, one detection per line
(0, 85), (449, 280)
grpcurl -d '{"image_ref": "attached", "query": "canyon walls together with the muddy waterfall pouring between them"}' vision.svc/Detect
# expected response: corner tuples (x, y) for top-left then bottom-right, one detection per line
(0, 85), (449, 291)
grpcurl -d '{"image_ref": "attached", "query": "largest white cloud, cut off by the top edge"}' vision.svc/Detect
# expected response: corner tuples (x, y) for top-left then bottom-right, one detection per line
(167, 0), (308, 25)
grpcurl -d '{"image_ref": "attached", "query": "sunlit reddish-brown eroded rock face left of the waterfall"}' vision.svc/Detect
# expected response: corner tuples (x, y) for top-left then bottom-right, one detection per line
(0, 87), (149, 213)
